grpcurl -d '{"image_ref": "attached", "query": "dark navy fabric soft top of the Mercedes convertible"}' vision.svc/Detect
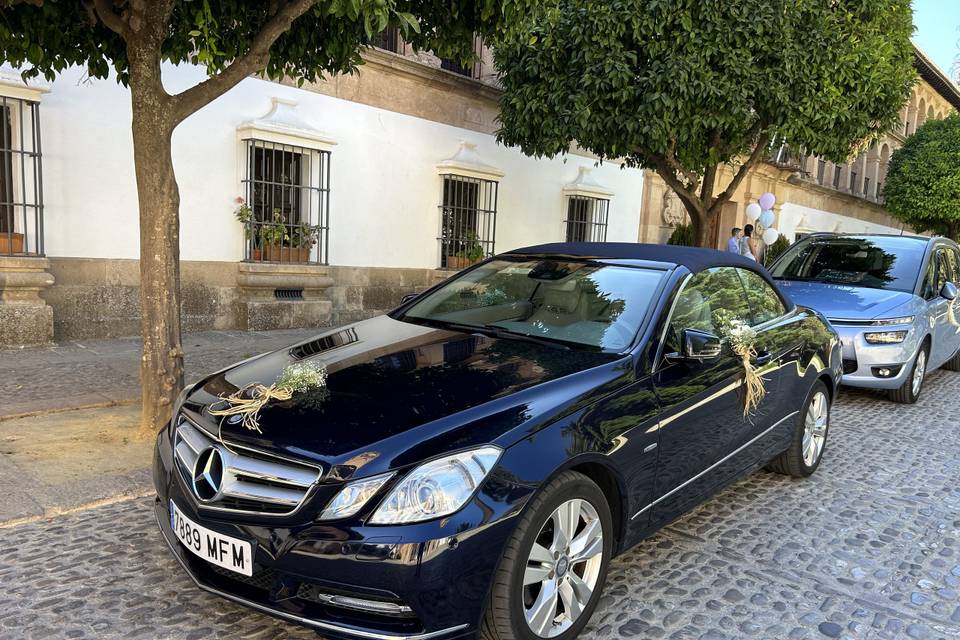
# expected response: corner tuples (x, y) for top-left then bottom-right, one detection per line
(509, 242), (766, 275)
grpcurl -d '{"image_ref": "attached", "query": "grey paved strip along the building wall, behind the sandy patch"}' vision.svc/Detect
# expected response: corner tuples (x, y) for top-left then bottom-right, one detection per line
(0, 329), (324, 421)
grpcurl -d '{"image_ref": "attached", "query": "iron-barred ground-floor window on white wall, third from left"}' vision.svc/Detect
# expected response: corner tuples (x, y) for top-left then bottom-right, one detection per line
(439, 174), (499, 269)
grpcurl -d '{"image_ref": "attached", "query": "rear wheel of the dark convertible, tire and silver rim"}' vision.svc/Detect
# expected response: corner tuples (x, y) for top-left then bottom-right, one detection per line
(767, 380), (830, 478)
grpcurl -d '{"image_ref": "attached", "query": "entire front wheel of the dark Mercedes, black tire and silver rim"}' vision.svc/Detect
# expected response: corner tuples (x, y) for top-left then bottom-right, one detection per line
(480, 471), (614, 640)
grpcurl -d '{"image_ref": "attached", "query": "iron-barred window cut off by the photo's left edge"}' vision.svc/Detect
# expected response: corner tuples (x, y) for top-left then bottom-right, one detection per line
(0, 96), (43, 256)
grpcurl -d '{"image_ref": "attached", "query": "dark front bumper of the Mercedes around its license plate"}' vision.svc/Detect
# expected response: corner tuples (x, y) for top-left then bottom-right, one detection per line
(154, 434), (514, 640)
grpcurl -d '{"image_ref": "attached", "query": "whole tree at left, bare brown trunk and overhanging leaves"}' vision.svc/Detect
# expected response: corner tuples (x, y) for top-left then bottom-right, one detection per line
(0, 0), (511, 436)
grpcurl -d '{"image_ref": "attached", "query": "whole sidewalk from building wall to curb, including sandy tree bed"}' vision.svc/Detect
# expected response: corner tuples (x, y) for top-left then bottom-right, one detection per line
(0, 329), (320, 527)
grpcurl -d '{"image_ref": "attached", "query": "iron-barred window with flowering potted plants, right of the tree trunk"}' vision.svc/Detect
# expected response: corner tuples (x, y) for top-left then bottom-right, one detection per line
(243, 139), (330, 264)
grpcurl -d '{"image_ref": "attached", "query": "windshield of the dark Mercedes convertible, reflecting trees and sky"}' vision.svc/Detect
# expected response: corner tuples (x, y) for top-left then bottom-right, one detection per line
(401, 258), (664, 351)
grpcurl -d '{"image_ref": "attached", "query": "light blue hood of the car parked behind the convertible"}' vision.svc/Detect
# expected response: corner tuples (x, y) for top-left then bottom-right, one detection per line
(777, 280), (915, 320)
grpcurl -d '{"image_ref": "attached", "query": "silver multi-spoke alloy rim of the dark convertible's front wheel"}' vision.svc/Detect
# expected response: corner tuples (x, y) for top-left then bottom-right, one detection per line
(523, 498), (603, 638)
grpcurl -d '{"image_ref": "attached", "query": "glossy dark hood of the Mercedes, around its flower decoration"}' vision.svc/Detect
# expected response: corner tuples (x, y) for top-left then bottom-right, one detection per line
(184, 316), (632, 475)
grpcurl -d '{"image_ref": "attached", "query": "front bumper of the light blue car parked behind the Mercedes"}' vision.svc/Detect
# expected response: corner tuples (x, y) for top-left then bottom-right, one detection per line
(833, 324), (920, 389)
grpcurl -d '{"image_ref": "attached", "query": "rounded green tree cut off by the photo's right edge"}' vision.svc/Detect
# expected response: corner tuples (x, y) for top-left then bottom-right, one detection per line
(883, 113), (960, 240)
